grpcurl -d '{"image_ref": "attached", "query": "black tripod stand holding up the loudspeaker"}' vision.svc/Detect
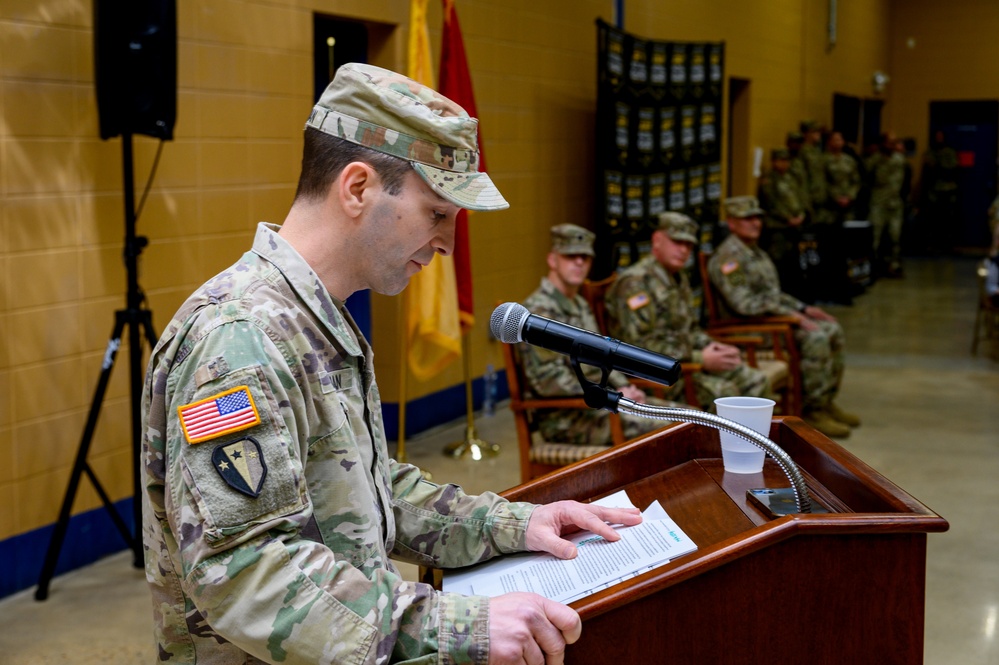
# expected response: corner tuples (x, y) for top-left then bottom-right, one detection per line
(35, 133), (157, 600)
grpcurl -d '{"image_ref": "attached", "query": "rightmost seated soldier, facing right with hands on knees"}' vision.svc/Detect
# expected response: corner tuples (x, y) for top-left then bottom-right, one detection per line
(708, 196), (860, 437)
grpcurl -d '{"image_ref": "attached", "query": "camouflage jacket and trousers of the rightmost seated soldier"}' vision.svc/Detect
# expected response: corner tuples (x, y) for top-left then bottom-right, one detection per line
(708, 235), (845, 412)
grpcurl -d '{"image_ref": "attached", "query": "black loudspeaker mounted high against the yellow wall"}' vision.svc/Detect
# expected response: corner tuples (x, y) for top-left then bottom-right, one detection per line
(93, 0), (177, 141)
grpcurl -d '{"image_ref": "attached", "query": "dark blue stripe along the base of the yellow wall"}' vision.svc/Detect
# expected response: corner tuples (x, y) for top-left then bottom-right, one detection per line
(0, 371), (510, 598)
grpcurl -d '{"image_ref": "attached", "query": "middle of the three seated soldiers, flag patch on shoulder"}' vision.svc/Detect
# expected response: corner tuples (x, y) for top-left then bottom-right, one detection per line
(606, 212), (770, 411)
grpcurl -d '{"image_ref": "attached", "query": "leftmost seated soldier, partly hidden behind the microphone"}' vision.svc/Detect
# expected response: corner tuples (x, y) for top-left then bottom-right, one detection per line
(519, 224), (684, 445)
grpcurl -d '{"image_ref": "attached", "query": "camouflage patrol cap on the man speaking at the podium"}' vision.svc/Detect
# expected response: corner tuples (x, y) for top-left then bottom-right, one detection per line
(305, 63), (510, 210)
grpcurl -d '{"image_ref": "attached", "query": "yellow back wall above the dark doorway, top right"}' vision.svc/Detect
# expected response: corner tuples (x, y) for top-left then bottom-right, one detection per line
(885, 0), (999, 151)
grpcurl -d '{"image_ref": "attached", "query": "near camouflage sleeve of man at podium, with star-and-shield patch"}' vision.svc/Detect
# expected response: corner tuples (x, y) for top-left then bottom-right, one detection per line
(162, 322), (500, 663)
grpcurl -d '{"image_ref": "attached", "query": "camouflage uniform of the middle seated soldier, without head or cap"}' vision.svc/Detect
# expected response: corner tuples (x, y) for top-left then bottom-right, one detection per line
(606, 213), (770, 411)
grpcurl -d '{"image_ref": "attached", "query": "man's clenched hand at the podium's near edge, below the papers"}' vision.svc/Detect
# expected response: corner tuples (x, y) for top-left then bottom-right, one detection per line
(489, 593), (583, 665)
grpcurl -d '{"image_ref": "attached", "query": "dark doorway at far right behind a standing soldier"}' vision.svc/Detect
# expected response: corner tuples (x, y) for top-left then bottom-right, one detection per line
(929, 100), (999, 250)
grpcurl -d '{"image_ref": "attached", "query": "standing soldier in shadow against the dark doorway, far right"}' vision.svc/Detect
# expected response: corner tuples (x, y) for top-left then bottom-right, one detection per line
(918, 130), (960, 251)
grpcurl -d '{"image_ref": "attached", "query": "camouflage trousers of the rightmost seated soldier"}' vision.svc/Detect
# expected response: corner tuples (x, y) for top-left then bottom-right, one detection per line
(794, 321), (845, 412)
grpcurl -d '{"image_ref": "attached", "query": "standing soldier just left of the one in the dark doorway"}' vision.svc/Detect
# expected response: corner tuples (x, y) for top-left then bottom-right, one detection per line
(867, 132), (906, 277)
